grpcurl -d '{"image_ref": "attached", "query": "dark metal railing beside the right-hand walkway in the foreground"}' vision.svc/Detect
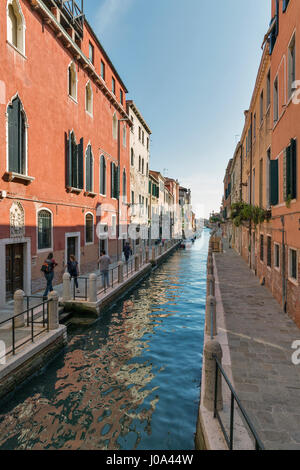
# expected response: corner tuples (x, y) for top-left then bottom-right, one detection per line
(213, 356), (264, 450)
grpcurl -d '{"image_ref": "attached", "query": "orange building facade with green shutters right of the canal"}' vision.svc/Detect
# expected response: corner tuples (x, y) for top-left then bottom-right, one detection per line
(223, 0), (300, 326)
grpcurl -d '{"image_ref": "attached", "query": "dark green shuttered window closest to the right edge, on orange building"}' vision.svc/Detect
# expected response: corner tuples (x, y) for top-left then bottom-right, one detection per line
(283, 139), (297, 201)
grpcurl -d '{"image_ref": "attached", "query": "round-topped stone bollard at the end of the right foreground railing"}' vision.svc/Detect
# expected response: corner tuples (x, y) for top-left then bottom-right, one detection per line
(203, 340), (223, 411)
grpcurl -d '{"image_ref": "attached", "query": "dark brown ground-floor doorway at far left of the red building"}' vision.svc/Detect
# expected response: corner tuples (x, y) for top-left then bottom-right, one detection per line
(5, 243), (24, 301)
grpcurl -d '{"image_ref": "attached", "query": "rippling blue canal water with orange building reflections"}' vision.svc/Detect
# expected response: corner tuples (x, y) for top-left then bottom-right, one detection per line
(0, 230), (209, 450)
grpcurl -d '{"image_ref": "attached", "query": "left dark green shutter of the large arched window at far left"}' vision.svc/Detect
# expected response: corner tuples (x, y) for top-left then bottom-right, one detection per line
(8, 99), (21, 173)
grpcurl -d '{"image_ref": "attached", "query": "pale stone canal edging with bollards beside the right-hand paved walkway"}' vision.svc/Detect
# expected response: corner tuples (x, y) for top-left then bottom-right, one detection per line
(195, 235), (253, 450)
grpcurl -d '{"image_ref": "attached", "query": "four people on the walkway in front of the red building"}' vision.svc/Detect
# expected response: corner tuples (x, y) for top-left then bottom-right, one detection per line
(41, 242), (132, 299)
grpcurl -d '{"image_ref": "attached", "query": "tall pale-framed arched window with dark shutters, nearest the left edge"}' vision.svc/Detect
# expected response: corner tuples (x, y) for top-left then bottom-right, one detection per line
(7, 96), (27, 175)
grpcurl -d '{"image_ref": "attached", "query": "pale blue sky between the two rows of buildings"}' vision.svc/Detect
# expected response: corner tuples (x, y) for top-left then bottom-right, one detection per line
(84, 0), (271, 217)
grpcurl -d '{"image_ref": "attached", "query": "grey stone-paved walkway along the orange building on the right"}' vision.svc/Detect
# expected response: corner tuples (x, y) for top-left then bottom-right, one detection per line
(215, 250), (300, 450)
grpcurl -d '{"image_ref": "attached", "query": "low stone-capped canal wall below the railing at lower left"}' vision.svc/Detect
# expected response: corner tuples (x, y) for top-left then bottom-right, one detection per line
(0, 325), (67, 400)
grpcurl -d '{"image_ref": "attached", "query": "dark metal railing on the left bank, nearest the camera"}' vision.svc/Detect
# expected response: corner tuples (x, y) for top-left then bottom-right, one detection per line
(0, 296), (52, 361)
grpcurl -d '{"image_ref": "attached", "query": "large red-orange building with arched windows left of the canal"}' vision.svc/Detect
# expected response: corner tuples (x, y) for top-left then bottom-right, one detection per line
(0, 0), (131, 305)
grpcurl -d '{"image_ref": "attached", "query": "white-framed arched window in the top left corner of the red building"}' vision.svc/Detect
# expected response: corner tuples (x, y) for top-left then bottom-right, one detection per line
(7, 0), (26, 54)
